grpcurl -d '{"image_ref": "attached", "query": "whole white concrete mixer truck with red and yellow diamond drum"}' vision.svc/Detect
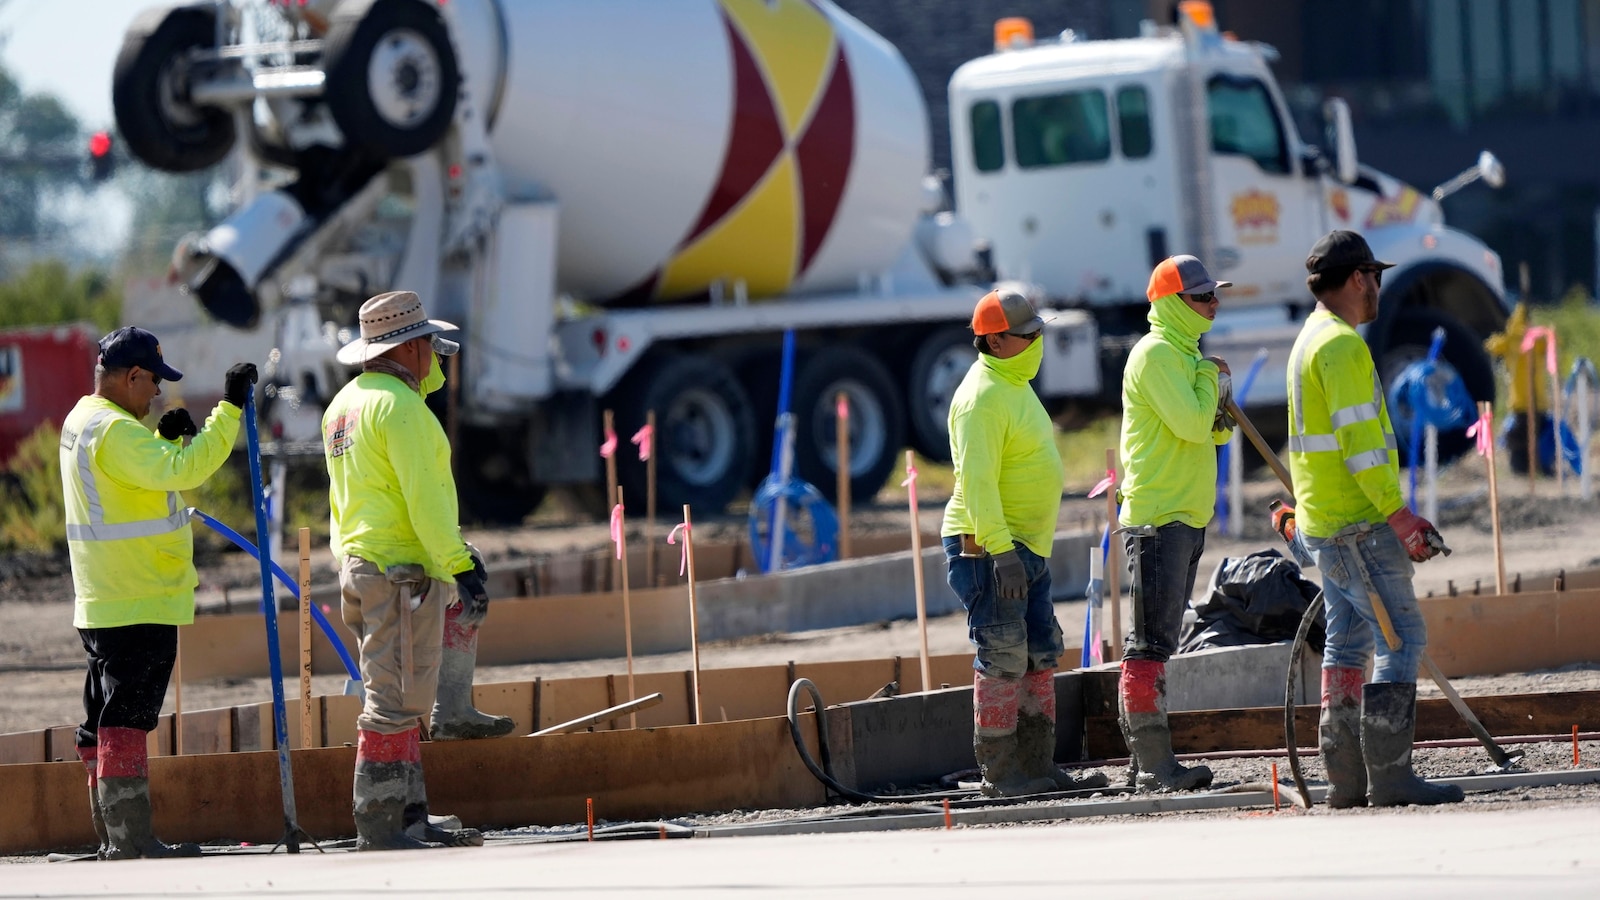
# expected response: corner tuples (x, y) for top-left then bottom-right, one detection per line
(114, 0), (1504, 519)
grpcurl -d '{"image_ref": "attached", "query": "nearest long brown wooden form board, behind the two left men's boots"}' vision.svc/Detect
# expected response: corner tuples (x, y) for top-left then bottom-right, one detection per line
(0, 716), (824, 854)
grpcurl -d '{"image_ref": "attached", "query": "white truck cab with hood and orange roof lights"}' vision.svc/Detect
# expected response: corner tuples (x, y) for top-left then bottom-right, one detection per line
(949, 3), (1506, 429)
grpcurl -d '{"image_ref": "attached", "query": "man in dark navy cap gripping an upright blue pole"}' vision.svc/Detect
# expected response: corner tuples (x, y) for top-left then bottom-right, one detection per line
(61, 327), (256, 860)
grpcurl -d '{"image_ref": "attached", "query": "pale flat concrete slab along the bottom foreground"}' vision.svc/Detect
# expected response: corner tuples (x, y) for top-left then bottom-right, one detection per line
(0, 807), (1600, 900)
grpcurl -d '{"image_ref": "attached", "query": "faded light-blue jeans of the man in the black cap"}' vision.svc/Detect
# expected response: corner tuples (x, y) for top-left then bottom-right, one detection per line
(1306, 524), (1427, 682)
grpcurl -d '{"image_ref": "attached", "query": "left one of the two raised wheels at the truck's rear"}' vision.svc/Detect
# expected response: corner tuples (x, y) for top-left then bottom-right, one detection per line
(110, 6), (234, 171)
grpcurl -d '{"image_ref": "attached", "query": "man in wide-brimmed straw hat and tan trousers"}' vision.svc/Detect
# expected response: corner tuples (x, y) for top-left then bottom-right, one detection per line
(322, 291), (490, 850)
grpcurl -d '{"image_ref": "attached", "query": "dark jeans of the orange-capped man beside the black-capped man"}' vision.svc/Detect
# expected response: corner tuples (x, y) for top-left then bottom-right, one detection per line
(1122, 522), (1205, 663)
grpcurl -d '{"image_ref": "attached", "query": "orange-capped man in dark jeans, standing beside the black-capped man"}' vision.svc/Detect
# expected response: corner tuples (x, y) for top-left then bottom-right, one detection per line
(1117, 256), (1234, 791)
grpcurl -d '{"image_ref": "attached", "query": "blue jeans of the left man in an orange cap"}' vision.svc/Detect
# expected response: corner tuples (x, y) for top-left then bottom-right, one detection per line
(944, 536), (1062, 677)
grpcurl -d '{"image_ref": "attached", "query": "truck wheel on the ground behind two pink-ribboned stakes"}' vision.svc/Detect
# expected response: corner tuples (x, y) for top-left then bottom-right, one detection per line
(608, 356), (755, 517)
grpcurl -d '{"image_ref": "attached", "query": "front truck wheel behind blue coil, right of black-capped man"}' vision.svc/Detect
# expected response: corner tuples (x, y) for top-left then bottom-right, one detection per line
(1374, 307), (1494, 466)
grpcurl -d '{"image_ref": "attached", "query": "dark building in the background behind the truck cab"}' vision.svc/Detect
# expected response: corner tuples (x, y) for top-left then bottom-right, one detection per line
(837, 0), (1600, 301)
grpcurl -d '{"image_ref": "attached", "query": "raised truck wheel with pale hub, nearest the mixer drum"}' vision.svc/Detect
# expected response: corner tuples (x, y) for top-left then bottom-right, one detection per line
(323, 0), (461, 159)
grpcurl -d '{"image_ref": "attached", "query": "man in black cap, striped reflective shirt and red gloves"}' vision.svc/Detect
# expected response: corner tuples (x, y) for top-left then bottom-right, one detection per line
(1274, 231), (1461, 807)
